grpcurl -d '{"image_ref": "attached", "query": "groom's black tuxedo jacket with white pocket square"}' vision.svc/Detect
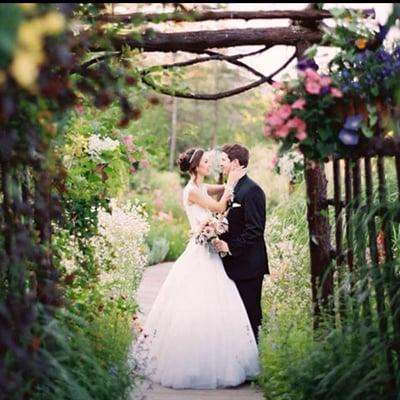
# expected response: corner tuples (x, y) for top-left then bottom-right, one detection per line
(220, 175), (269, 281)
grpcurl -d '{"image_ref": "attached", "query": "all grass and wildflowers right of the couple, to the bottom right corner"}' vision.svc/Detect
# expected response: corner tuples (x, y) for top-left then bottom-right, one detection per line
(259, 163), (400, 400)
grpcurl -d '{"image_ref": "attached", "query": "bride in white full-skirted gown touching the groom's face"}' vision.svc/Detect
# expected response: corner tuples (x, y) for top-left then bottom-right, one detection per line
(131, 148), (259, 389)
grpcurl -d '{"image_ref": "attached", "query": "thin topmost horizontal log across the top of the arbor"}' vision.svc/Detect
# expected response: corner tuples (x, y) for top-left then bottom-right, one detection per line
(98, 8), (375, 23)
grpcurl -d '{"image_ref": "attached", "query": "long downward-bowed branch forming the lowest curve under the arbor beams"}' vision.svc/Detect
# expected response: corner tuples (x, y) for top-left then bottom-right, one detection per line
(142, 52), (296, 100)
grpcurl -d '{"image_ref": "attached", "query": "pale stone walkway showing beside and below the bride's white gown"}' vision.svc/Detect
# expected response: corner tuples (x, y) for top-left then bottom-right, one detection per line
(131, 263), (263, 400)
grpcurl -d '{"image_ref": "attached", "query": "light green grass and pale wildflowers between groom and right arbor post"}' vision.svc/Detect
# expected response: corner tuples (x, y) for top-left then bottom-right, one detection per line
(258, 183), (312, 400)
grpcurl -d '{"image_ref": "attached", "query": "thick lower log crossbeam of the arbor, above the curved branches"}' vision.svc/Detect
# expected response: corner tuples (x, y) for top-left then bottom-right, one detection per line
(90, 26), (323, 53)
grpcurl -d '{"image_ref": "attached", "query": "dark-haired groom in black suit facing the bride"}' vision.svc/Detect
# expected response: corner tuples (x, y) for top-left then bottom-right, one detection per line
(214, 144), (269, 341)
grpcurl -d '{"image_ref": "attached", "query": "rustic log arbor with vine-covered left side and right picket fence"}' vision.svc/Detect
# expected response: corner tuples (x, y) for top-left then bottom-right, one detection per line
(0, 6), (400, 397)
